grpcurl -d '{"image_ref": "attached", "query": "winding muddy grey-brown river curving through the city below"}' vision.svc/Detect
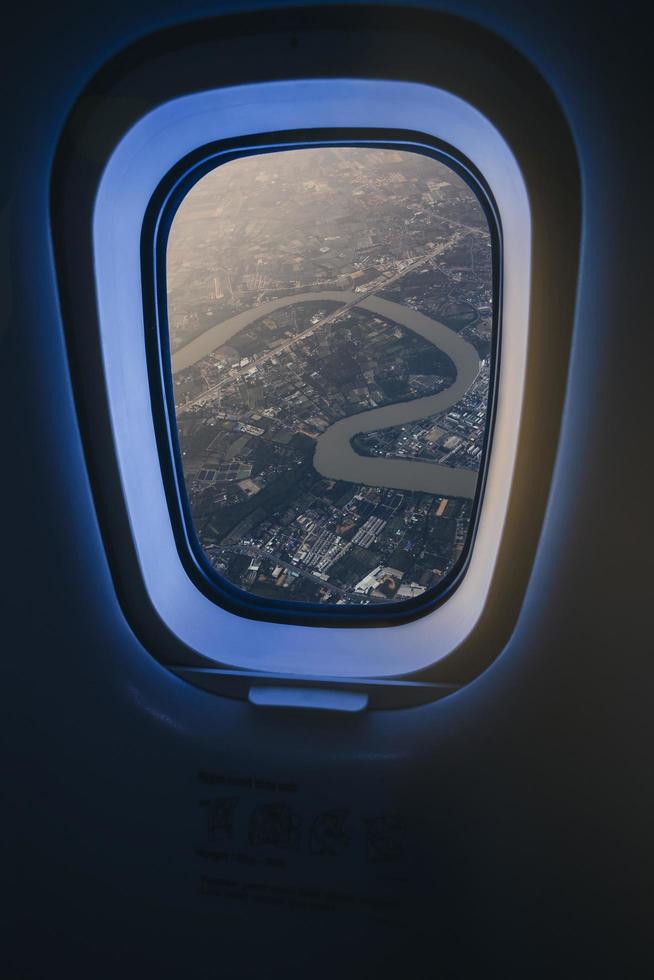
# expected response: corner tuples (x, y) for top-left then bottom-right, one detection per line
(172, 290), (480, 497)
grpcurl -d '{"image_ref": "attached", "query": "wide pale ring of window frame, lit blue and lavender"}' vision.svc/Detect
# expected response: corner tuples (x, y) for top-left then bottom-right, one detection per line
(65, 78), (531, 678)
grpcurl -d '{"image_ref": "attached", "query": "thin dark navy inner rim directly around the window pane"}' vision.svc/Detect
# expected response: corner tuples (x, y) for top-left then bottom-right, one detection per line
(141, 128), (503, 628)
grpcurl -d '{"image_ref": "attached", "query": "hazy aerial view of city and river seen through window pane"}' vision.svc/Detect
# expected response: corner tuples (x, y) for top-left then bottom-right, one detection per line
(166, 146), (493, 605)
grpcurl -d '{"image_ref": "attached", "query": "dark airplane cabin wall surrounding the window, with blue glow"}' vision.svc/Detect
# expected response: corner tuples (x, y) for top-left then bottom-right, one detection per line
(0, 0), (654, 980)
